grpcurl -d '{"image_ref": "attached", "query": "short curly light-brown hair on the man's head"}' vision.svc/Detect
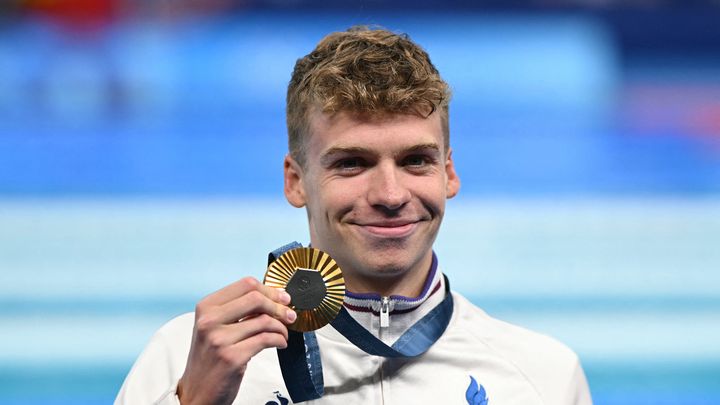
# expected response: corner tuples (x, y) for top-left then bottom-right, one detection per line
(287, 26), (450, 166)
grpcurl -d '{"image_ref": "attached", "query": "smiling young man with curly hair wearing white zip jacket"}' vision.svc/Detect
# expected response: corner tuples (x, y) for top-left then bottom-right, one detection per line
(116, 27), (591, 405)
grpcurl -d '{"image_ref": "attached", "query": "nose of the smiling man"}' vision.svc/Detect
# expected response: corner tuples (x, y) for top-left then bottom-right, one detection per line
(368, 164), (411, 210)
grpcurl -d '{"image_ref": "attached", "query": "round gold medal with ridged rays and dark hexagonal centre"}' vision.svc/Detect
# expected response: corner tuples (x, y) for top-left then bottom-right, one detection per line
(263, 248), (345, 332)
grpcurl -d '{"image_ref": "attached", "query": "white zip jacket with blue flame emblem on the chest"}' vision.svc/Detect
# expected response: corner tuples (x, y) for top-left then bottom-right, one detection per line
(115, 269), (592, 405)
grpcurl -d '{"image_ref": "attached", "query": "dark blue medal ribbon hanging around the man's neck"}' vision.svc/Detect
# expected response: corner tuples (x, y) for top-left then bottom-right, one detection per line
(268, 242), (453, 403)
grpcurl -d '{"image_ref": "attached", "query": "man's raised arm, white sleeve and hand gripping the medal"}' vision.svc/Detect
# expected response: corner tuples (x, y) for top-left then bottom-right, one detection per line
(115, 278), (297, 405)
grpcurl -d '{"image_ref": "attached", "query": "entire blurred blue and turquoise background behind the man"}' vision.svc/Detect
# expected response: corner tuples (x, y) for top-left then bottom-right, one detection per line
(0, 0), (720, 405)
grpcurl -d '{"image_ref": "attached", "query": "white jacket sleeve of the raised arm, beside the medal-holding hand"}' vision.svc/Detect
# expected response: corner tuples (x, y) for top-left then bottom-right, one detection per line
(115, 318), (187, 405)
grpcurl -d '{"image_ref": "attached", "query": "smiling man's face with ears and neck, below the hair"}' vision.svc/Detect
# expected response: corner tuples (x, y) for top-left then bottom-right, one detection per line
(285, 112), (460, 295)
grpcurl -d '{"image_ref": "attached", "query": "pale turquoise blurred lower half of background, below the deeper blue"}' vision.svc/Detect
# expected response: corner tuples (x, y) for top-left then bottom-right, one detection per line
(0, 199), (720, 405)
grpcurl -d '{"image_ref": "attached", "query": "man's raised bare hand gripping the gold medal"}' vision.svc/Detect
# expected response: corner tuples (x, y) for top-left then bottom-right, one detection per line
(177, 277), (297, 404)
